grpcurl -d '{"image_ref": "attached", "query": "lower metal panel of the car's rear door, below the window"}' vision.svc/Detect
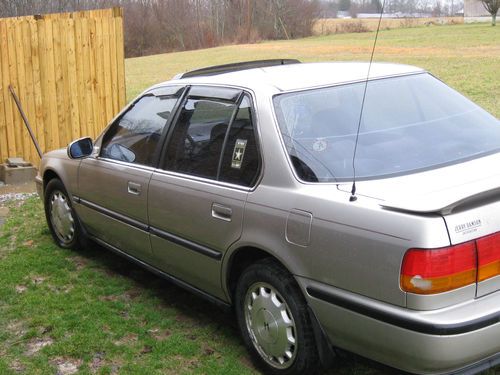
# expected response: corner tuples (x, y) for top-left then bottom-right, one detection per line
(148, 170), (247, 299)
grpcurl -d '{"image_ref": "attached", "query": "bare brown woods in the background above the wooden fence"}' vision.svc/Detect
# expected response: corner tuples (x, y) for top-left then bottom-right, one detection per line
(0, 0), (321, 57)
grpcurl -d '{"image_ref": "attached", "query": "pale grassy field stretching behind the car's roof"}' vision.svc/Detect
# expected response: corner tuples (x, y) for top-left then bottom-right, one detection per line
(125, 23), (500, 117)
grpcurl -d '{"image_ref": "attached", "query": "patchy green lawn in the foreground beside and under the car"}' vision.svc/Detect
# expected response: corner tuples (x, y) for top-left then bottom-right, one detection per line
(0, 198), (398, 375)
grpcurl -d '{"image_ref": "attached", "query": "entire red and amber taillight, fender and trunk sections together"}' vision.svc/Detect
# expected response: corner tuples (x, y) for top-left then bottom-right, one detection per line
(401, 233), (500, 294)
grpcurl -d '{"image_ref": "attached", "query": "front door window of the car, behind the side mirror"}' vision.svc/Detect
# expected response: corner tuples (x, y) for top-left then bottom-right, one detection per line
(100, 88), (182, 166)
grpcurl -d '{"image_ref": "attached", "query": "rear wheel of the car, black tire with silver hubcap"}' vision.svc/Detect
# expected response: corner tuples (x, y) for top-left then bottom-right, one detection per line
(235, 259), (320, 375)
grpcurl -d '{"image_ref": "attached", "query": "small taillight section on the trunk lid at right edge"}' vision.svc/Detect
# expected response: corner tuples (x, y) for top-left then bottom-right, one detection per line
(476, 233), (500, 282)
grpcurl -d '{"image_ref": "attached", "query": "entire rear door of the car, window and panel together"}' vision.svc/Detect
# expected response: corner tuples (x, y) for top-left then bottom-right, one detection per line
(148, 87), (260, 298)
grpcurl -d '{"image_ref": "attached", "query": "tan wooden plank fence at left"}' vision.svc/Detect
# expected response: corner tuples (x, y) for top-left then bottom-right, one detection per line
(0, 8), (125, 164)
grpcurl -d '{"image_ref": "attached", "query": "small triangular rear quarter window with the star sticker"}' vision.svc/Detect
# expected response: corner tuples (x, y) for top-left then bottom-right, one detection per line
(219, 95), (259, 186)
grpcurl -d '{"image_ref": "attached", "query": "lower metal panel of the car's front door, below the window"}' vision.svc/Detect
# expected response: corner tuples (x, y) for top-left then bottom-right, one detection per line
(77, 157), (152, 261)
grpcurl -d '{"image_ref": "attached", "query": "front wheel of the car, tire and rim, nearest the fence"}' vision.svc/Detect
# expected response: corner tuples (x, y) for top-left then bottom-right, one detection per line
(44, 178), (87, 250)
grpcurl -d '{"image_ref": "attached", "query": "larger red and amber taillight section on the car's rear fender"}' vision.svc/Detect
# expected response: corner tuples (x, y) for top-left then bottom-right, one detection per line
(401, 241), (477, 294)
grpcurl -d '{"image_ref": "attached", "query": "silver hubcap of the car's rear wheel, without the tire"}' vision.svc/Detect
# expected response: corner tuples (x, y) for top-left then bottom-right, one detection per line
(245, 282), (297, 369)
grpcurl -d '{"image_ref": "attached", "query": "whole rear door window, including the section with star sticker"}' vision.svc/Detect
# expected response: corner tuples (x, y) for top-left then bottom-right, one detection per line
(163, 88), (260, 186)
